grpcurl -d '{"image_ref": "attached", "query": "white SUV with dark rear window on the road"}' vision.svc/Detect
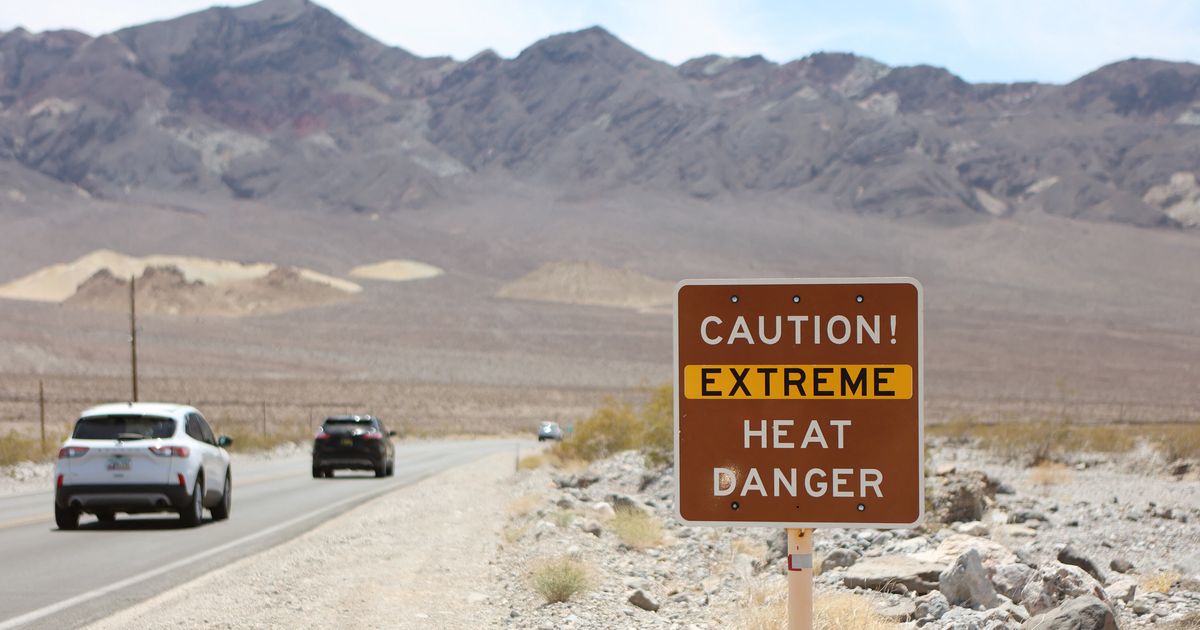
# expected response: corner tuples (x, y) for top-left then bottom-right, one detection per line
(54, 402), (233, 529)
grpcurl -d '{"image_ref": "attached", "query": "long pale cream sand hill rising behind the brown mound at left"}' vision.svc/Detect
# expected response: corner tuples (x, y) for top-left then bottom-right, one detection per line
(0, 250), (362, 302)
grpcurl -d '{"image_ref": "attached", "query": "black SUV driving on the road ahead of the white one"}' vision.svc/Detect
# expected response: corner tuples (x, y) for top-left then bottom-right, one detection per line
(312, 415), (396, 478)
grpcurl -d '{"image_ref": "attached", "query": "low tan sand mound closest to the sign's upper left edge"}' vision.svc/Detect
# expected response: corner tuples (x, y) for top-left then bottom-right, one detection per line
(497, 262), (674, 312)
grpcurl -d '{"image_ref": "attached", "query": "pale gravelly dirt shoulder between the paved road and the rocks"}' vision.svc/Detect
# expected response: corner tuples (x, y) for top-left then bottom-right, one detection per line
(89, 454), (512, 630)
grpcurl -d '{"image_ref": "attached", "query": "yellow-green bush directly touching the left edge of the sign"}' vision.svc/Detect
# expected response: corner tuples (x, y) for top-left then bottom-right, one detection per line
(553, 385), (674, 466)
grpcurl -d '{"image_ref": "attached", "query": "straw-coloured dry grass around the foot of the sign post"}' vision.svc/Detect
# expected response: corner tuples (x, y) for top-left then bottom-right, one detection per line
(738, 580), (901, 630)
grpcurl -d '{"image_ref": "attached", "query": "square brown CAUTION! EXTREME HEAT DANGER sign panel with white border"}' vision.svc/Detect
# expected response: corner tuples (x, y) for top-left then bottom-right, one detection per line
(674, 278), (924, 528)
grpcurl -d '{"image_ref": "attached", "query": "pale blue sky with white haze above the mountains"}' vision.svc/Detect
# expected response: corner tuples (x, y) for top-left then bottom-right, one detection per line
(0, 0), (1200, 83)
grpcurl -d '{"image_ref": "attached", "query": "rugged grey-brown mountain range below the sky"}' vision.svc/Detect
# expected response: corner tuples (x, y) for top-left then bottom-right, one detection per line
(0, 0), (1200, 226)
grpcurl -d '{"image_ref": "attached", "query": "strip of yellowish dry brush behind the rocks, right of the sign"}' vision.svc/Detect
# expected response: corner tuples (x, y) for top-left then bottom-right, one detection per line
(926, 416), (1200, 463)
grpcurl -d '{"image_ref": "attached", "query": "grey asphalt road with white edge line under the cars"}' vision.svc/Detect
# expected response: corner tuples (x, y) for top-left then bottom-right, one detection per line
(0, 440), (532, 630)
